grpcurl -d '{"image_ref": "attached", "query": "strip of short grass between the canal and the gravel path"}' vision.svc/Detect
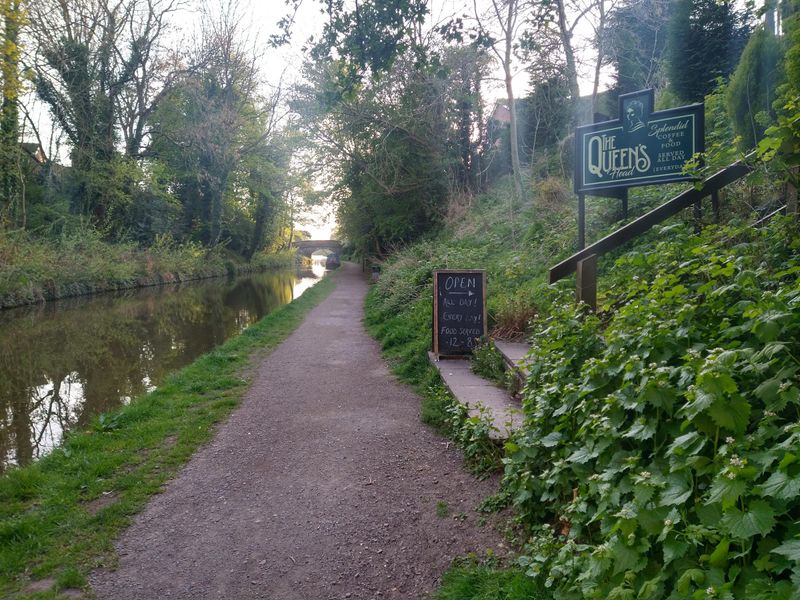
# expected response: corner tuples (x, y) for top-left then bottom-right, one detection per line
(0, 276), (335, 598)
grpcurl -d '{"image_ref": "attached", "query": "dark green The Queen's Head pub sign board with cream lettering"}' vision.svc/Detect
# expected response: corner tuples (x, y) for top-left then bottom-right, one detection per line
(575, 89), (705, 195)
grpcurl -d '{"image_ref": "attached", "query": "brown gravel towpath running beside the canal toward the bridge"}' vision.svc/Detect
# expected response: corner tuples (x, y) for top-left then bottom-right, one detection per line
(92, 264), (502, 600)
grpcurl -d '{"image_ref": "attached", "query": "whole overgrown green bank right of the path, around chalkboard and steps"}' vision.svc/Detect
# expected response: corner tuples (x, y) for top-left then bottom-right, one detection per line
(367, 176), (800, 600)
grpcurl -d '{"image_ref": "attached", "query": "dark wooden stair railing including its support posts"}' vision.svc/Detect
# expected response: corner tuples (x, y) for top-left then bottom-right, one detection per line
(550, 156), (756, 288)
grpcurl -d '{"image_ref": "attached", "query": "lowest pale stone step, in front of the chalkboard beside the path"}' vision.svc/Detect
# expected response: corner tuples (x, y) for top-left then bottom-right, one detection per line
(428, 352), (522, 440)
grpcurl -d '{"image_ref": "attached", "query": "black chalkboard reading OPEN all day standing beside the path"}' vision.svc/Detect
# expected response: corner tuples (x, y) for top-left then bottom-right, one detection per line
(433, 270), (486, 356)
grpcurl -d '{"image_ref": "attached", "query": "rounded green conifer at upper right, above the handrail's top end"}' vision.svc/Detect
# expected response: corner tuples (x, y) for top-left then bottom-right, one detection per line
(727, 27), (784, 150)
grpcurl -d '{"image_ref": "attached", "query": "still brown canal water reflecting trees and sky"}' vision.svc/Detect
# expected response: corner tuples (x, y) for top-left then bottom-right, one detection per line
(0, 263), (325, 473)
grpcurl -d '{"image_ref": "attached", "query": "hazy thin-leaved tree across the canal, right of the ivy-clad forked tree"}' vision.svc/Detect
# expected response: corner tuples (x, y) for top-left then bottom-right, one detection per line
(148, 4), (283, 250)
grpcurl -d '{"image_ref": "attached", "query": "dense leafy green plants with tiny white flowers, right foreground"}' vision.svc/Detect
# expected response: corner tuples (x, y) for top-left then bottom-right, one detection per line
(504, 221), (800, 600)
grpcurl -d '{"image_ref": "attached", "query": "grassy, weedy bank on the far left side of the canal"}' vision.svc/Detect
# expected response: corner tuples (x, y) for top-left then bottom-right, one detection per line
(0, 229), (294, 309)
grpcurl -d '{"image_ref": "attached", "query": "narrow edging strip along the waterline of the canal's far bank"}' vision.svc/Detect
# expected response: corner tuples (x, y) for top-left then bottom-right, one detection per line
(0, 254), (294, 310)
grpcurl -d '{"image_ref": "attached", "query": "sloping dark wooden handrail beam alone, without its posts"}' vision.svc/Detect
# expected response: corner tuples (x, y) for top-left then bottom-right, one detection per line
(550, 155), (753, 283)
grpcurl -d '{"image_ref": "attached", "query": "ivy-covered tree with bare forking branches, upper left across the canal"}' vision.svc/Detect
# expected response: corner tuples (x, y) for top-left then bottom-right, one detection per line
(30, 0), (180, 226)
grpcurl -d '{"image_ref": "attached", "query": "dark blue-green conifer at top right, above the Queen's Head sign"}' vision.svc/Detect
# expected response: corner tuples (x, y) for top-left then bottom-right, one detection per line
(667, 0), (750, 102)
